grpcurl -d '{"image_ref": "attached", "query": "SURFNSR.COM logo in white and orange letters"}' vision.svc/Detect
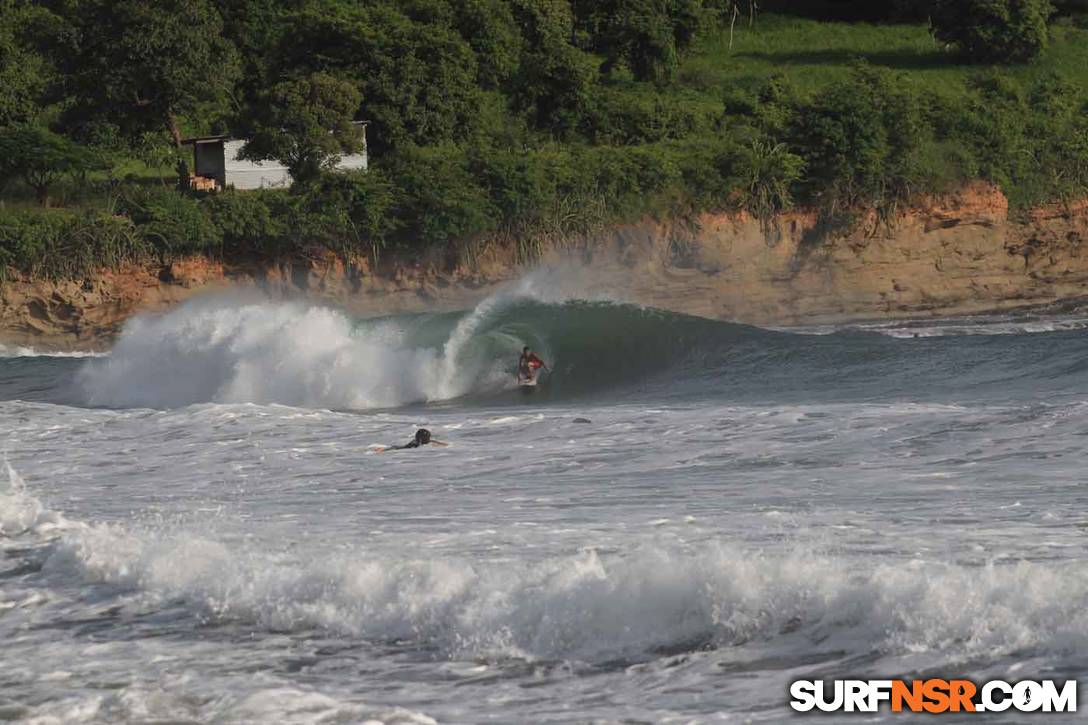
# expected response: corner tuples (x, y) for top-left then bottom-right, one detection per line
(790, 679), (1077, 713)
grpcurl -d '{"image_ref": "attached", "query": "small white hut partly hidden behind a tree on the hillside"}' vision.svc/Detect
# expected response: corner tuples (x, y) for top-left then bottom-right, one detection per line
(182, 123), (367, 191)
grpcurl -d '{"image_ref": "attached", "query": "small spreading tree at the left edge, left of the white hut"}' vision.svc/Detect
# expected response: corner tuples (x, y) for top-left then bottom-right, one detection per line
(0, 126), (107, 206)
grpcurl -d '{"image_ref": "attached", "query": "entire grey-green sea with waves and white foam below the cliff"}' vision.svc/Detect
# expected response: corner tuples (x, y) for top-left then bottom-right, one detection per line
(0, 283), (1088, 723)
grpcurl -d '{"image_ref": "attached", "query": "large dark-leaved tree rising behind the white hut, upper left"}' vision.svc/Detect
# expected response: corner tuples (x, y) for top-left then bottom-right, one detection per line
(62, 0), (239, 146)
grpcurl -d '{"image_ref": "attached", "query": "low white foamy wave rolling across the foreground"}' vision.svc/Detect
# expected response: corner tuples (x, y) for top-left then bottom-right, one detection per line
(0, 467), (1088, 665)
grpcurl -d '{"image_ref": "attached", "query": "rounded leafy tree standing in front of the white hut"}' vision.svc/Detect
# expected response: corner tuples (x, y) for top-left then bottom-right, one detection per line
(242, 73), (363, 183)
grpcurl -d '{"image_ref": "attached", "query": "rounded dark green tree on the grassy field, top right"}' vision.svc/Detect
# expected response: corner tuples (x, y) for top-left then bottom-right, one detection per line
(930, 0), (1054, 63)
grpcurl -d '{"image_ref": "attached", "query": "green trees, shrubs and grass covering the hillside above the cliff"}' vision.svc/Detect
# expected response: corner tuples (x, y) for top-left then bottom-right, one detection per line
(0, 0), (1088, 279)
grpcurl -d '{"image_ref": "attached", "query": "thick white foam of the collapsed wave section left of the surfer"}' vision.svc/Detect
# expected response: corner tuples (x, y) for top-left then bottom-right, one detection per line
(78, 299), (511, 408)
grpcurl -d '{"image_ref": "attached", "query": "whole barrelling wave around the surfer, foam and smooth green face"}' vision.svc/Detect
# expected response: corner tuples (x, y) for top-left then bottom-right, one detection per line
(76, 280), (1088, 409)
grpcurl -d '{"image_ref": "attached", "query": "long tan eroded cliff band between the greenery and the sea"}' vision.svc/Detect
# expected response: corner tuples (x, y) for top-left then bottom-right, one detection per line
(0, 184), (1088, 348)
